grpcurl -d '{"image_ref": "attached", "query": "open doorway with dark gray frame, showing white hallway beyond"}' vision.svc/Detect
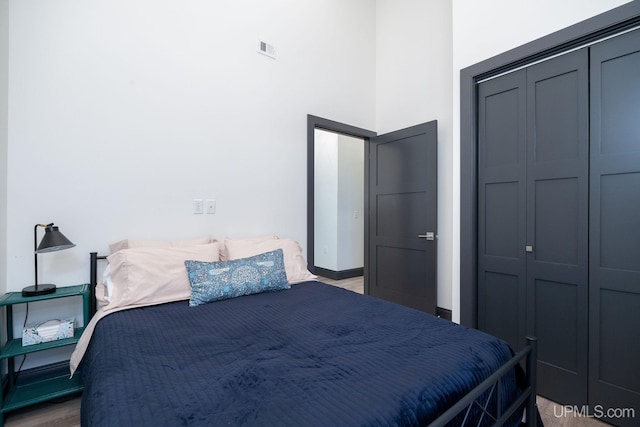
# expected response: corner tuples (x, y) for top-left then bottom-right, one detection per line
(307, 115), (375, 281)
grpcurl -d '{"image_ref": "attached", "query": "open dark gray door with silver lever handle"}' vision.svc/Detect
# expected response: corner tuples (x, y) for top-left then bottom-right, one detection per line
(365, 121), (438, 314)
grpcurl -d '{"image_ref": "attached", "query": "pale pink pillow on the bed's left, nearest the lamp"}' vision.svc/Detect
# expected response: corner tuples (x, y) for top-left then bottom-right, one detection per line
(97, 243), (220, 311)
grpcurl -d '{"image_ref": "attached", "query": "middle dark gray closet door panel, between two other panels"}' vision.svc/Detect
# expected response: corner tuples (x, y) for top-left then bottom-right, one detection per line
(526, 49), (589, 405)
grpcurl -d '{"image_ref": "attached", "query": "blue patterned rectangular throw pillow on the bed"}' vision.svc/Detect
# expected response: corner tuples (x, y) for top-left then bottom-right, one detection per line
(184, 249), (291, 307)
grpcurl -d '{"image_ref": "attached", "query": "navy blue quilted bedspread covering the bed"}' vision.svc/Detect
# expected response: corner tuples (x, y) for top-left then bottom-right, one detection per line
(80, 282), (517, 427)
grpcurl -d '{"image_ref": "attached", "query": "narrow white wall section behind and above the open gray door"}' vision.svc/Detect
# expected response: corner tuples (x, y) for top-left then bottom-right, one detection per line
(376, 0), (455, 309)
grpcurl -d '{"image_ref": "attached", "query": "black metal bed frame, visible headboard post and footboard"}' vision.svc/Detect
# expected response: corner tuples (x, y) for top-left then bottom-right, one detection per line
(90, 252), (538, 427)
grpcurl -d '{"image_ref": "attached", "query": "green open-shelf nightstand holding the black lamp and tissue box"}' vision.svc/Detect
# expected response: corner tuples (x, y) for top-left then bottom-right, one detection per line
(0, 284), (91, 426)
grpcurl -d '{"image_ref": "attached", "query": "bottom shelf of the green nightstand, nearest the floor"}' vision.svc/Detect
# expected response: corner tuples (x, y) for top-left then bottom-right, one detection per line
(1, 370), (83, 413)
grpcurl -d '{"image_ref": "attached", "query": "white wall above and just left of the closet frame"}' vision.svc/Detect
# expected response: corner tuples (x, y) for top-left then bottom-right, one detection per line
(452, 0), (628, 321)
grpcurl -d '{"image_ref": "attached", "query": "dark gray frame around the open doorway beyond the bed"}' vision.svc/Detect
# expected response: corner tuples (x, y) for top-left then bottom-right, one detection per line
(306, 114), (376, 286)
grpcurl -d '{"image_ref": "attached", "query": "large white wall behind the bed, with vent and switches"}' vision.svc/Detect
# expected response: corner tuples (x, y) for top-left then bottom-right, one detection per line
(5, 0), (375, 368)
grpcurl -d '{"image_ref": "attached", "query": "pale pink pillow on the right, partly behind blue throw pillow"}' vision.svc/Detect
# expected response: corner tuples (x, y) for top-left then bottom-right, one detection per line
(224, 239), (317, 284)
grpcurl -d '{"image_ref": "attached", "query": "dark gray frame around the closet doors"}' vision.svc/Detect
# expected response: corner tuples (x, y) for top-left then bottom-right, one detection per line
(460, 0), (640, 328)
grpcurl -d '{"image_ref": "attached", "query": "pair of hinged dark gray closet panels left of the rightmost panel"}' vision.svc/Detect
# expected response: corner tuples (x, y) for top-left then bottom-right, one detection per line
(478, 49), (589, 404)
